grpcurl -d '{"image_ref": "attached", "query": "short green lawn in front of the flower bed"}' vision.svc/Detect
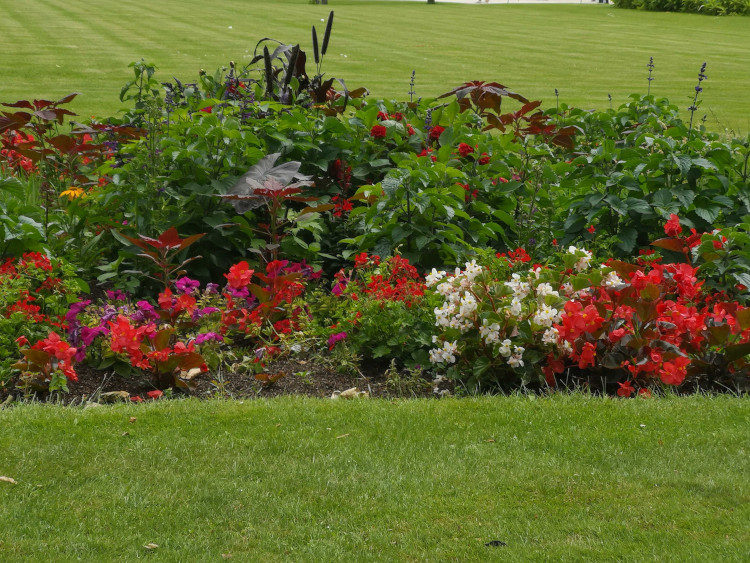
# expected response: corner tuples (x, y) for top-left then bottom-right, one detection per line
(0, 395), (750, 562)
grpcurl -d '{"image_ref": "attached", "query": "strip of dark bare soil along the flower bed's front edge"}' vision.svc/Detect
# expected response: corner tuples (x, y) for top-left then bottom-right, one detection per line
(0, 360), (453, 404)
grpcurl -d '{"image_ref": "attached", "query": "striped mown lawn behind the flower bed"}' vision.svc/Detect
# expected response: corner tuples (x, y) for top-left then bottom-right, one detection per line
(0, 0), (750, 132)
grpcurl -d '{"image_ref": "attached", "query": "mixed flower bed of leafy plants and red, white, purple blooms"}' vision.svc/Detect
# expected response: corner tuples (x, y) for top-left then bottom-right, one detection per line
(0, 16), (750, 397)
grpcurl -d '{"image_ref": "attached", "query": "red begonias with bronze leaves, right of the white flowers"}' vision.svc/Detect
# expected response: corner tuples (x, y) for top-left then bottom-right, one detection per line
(545, 242), (750, 396)
